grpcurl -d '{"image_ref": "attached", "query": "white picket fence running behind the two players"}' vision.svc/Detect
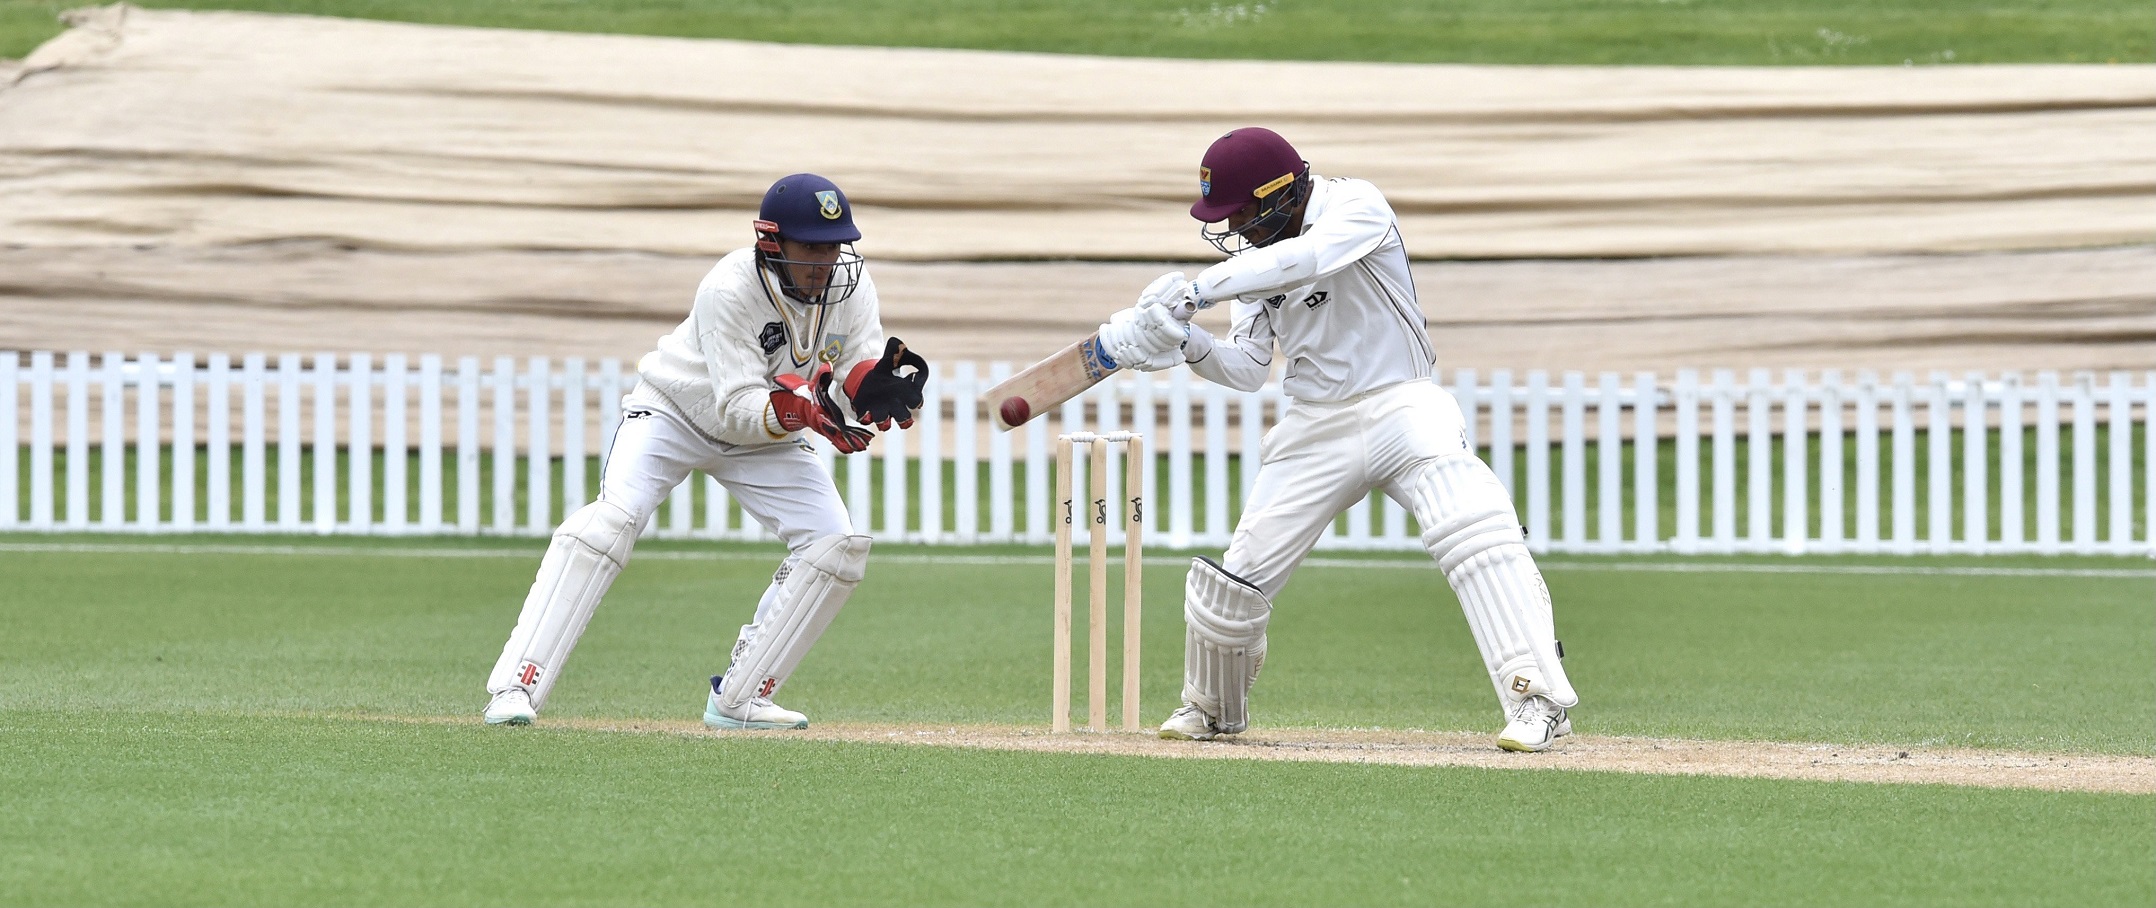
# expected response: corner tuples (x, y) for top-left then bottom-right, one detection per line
(0, 352), (2156, 554)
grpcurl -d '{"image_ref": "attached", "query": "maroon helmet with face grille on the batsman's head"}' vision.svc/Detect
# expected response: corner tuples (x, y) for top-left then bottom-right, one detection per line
(1190, 125), (1311, 254)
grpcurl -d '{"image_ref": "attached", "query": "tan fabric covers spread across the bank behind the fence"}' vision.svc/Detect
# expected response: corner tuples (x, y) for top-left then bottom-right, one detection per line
(0, 6), (2156, 371)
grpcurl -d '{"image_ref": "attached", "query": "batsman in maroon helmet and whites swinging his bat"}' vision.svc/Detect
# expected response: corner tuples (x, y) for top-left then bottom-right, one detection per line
(1097, 127), (1578, 751)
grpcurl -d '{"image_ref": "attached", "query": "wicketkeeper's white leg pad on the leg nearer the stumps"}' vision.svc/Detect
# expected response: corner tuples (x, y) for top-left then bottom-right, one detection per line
(718, 535), (869, 710)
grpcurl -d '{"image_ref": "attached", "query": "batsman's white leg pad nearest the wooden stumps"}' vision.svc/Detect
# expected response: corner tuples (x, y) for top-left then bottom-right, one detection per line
(1184, 559), (1272, 735)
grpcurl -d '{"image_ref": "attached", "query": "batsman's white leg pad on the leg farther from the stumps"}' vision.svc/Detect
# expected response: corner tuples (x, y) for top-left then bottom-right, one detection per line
(1412, 455), (1580, 707)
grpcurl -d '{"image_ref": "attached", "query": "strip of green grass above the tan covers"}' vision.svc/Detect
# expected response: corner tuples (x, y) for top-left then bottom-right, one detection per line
(0, 0), (2156, 65)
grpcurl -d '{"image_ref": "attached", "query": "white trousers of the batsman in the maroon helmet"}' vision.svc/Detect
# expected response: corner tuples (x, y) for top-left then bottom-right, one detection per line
(1220, 380), (1468, 600)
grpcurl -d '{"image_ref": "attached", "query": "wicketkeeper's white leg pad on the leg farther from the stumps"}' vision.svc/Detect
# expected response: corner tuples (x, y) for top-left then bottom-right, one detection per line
(487, 500), (636, 710)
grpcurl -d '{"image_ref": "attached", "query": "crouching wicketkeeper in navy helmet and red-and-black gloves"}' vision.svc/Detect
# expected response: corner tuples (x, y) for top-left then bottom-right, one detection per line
(485, 173), (927, 729)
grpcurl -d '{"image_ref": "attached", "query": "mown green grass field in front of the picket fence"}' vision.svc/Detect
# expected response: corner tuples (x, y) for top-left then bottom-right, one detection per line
(0, 535), (2156, 906)
